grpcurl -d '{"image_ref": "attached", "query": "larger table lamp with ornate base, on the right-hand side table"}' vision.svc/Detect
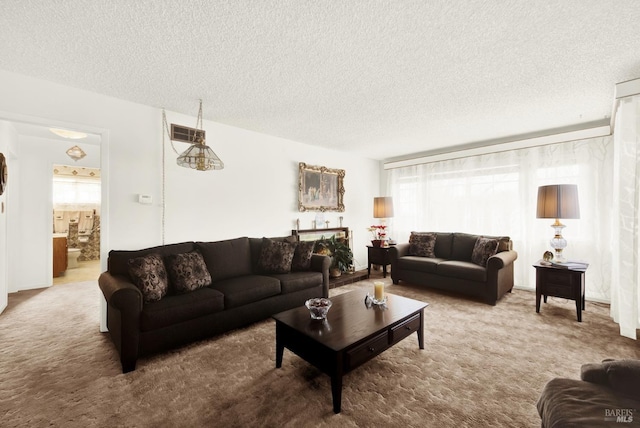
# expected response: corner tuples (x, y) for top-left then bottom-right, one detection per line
(536, 184), (580, 262)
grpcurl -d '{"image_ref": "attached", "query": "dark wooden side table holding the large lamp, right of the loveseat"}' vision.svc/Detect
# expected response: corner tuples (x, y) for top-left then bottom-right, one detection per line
(533, 263), (588, 322)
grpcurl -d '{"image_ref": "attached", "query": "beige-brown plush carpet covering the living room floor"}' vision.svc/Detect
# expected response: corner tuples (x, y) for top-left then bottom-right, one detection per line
(0, 278), (640, 427)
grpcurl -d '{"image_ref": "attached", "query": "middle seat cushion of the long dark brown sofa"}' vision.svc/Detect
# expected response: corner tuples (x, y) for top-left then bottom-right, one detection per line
(211, 275), (281, 309)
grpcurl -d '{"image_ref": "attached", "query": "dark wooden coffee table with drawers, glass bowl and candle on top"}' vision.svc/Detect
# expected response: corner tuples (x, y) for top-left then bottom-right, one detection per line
(273, 291), (428, 413)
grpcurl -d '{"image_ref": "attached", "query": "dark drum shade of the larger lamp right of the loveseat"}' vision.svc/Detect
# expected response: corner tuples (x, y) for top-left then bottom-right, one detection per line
(536, 184), (580, 219)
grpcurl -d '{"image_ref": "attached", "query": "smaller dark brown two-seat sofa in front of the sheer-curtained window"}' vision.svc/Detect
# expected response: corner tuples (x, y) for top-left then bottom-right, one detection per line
(389, 232), (518, 305)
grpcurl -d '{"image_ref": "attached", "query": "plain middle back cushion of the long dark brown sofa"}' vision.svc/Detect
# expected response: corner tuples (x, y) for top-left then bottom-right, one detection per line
(196, 237), (252, 282)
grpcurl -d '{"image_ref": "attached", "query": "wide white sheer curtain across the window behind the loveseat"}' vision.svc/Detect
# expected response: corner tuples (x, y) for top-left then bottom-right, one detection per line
(387, 137), (613, 301)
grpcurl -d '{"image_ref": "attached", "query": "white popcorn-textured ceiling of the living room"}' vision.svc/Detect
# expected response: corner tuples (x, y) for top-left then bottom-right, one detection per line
(0, 0), (640, 159)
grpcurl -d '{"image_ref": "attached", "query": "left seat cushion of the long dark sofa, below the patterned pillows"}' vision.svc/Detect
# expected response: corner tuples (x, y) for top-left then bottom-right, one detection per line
(140, 287), (224, 331)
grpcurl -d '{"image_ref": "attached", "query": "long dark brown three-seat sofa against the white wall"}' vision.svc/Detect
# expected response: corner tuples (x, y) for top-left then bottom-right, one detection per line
(98, 237), (330, 373)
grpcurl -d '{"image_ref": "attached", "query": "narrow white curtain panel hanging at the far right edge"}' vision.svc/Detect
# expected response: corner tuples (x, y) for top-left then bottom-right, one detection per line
(611, 96), (640, 339)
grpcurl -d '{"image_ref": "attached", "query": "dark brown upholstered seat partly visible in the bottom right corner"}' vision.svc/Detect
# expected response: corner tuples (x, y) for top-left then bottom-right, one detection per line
(537, 360), (640, 428)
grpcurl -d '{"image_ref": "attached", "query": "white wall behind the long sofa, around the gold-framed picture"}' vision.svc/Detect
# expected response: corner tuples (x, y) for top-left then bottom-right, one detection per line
(0, 71), (379, 289)
